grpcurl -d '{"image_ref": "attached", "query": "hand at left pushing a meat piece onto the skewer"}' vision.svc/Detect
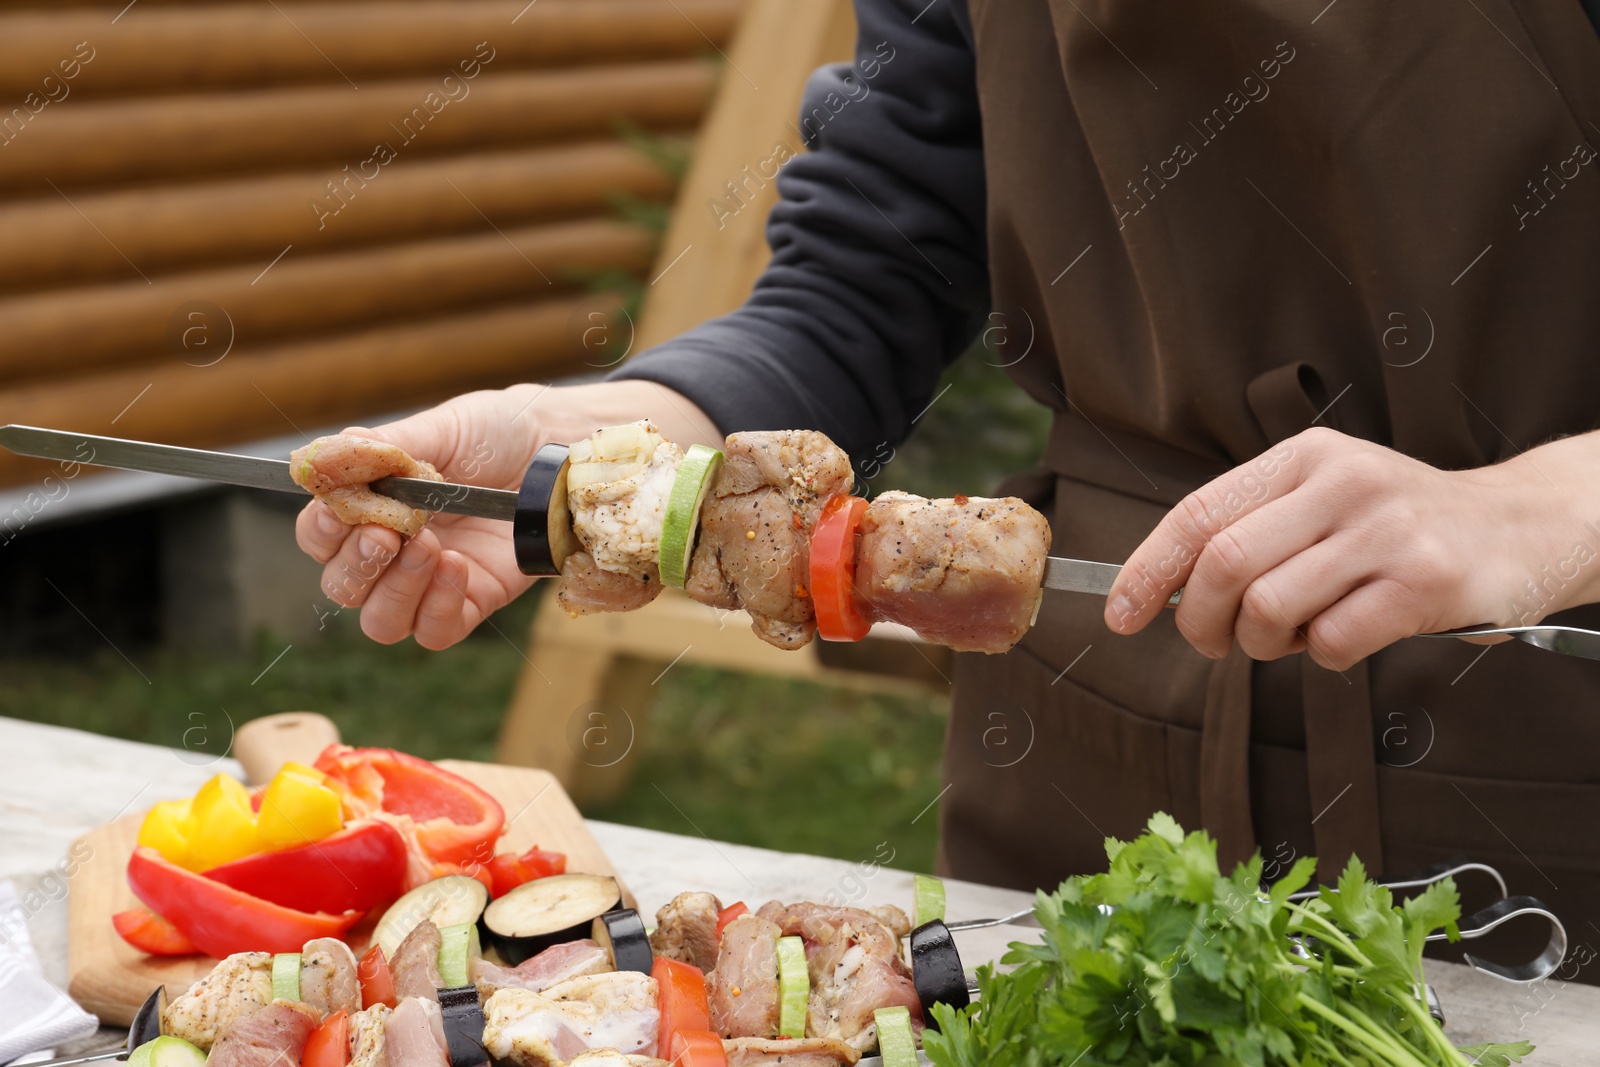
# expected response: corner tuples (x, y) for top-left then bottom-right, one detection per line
(294, 381), (720, 648)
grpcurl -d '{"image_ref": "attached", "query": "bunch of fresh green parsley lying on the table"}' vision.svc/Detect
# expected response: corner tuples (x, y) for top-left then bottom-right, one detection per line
(923, 814), (1533, 1067)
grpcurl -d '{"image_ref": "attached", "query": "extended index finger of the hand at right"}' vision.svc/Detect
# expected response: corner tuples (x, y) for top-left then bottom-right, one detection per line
(1106, 430), (1312, 633)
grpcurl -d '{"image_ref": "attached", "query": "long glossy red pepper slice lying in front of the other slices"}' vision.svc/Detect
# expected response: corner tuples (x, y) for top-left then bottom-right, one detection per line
(128, 848), (362, 960)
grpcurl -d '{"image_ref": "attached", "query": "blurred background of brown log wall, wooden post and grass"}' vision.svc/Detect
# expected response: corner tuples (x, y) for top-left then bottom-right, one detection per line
(0, 0), (1045, 869)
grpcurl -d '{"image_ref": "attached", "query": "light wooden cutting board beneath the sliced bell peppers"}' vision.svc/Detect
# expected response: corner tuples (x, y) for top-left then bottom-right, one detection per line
(67, 760), (634, 1025)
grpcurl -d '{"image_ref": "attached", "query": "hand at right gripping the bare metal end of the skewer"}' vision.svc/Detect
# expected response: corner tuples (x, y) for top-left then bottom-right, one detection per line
(1106, 427), (1600, 670)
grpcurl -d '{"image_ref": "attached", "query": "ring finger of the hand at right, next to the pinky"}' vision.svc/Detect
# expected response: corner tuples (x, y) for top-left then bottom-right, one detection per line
(1222, 533), (1373, 659)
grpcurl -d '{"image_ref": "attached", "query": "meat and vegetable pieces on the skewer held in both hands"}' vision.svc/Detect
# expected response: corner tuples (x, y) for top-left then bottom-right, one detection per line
(291, 421), (1050, 653)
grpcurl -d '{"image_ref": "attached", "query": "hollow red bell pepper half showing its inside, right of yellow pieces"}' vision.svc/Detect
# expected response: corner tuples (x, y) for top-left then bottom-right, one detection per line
(315, 745), (506, 864)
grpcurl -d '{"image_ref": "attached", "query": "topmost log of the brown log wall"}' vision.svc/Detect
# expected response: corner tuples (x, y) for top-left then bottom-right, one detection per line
(0, 0), (744, 98)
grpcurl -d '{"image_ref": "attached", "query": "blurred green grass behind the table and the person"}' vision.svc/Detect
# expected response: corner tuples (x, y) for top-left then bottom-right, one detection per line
(0, 352), (1046, 870)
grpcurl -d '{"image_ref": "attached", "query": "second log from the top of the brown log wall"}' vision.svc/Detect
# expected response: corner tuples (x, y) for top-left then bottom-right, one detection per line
(0, 61), (715, 195)
